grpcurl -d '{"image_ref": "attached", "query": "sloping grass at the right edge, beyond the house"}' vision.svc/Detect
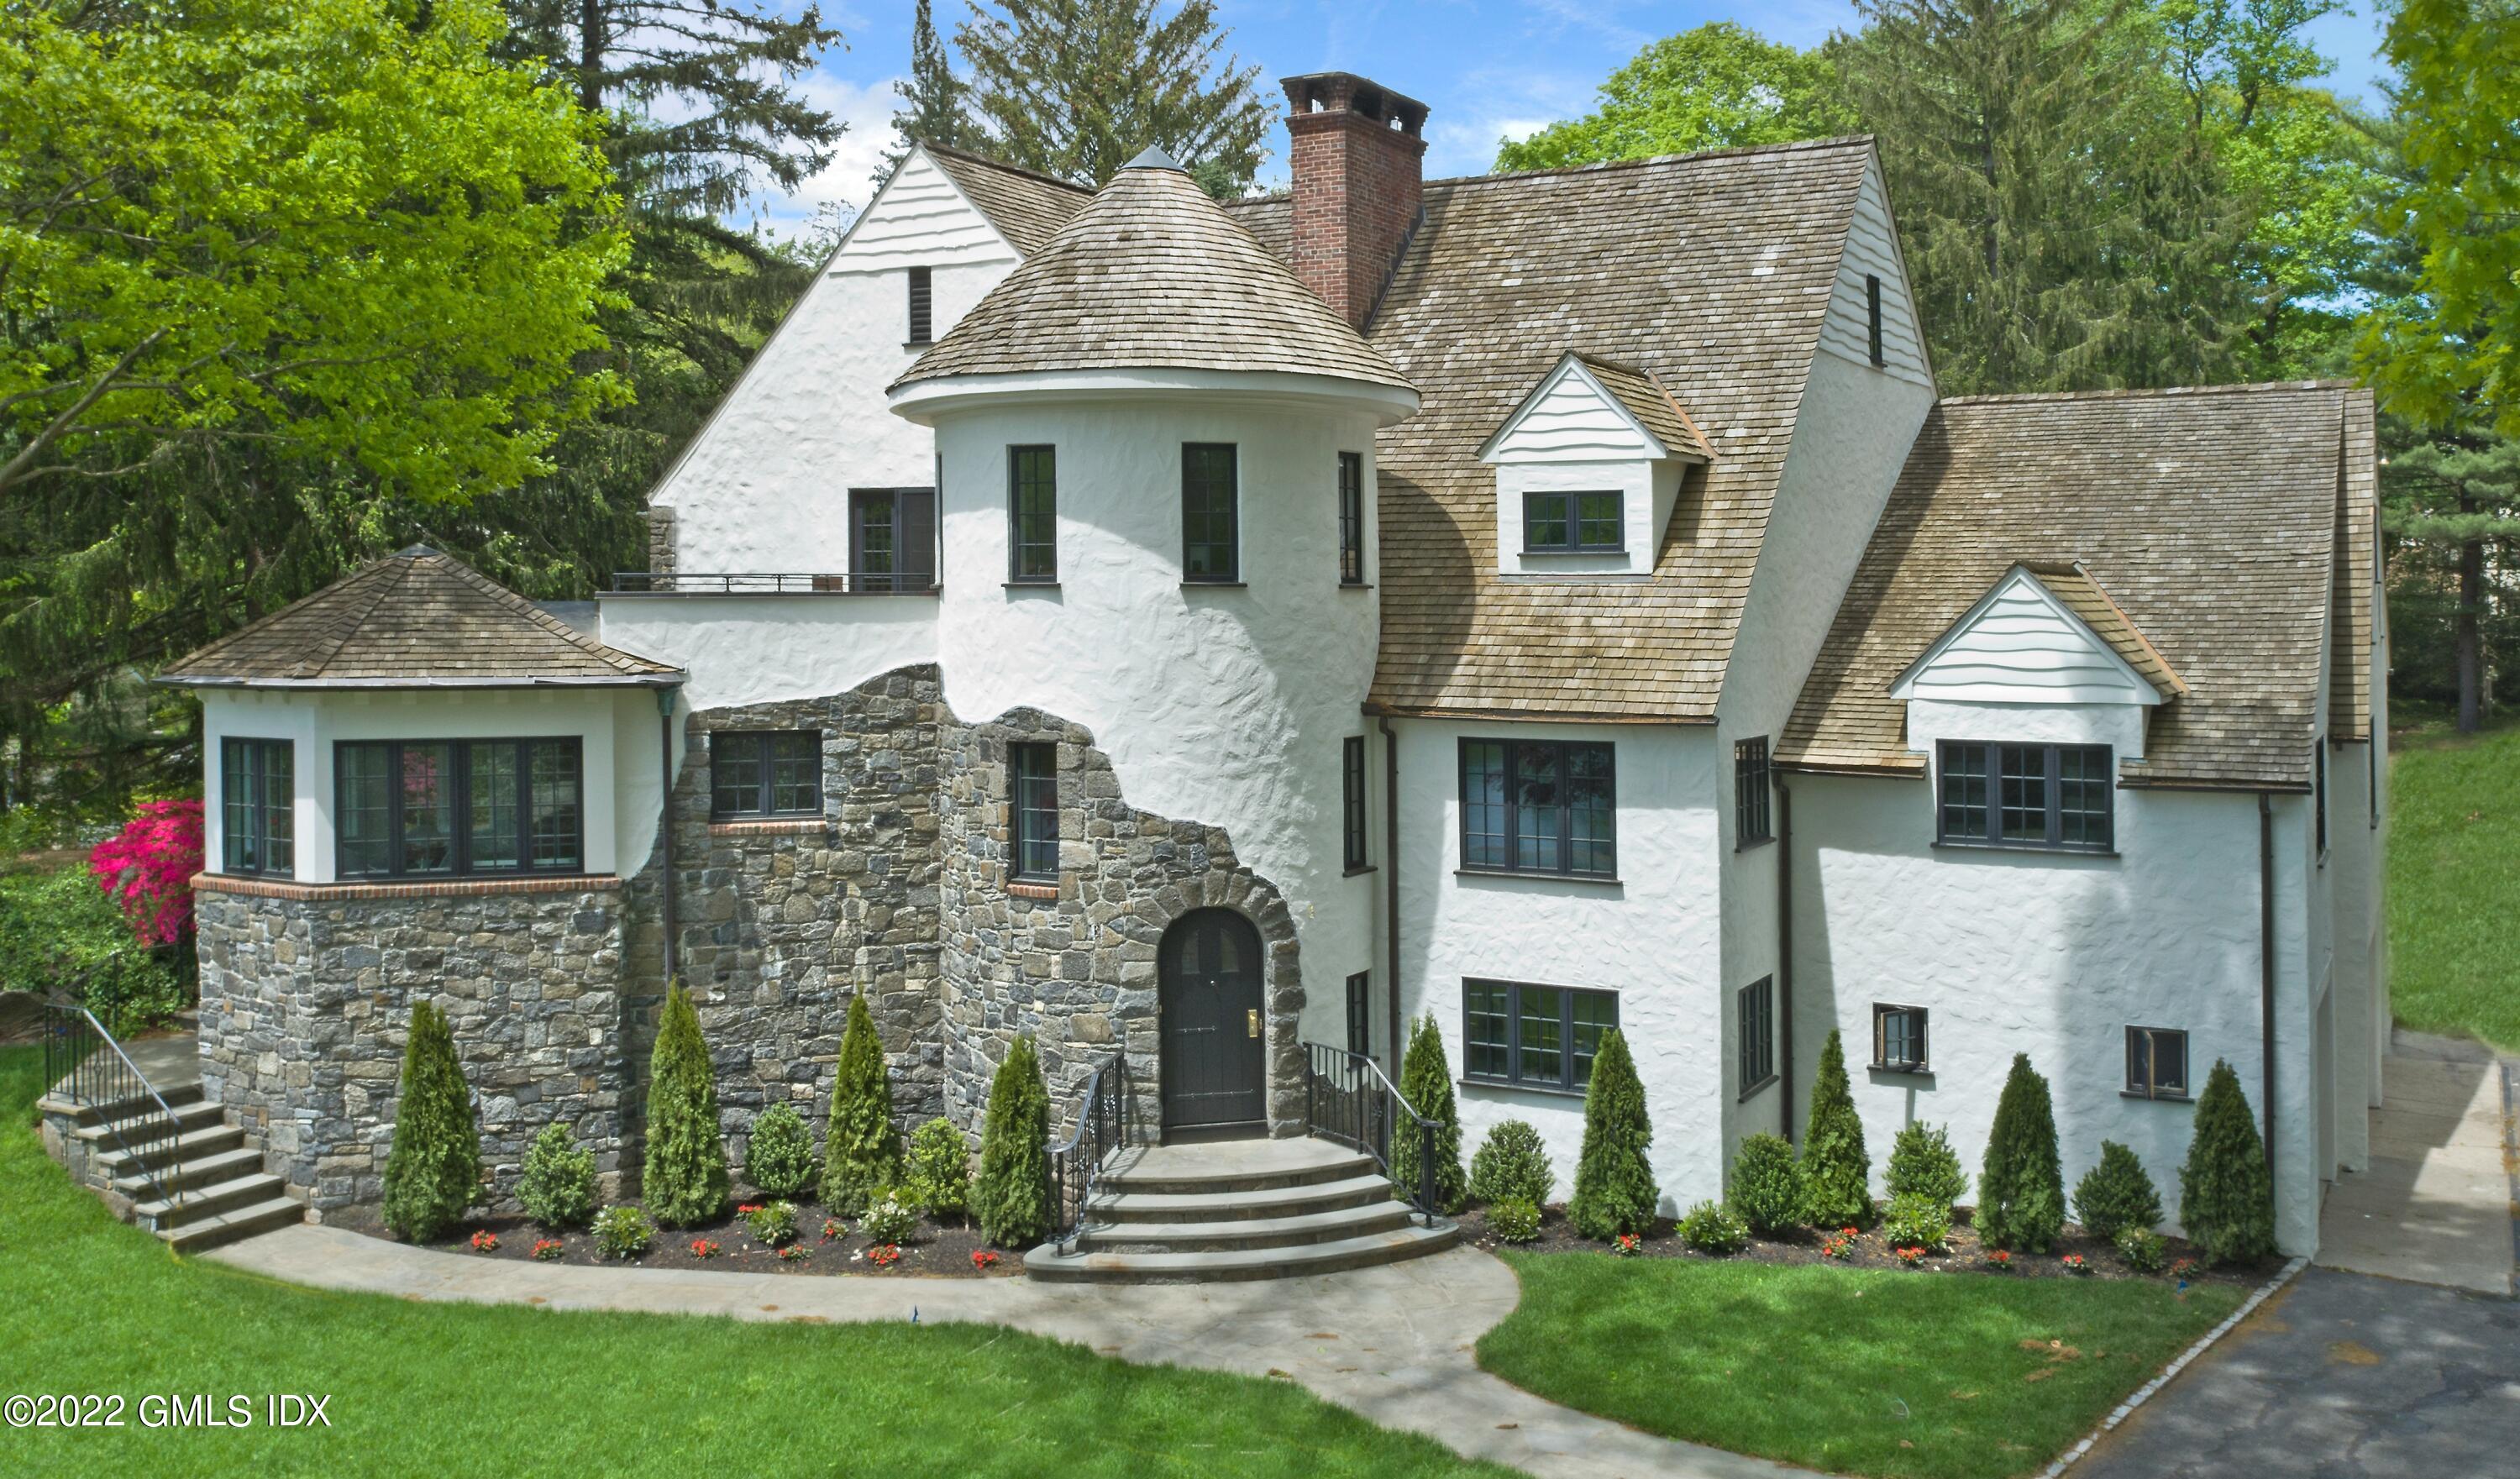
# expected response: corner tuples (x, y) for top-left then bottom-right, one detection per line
(2389, 716), (2520, 1053)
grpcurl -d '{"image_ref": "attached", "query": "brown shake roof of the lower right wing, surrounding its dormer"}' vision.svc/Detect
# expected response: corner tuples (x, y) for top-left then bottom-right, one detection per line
(1777, 380), (2371, 789)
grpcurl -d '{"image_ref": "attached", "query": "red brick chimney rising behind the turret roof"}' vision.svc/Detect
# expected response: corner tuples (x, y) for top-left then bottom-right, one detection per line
(1280, 73), (1426, 328)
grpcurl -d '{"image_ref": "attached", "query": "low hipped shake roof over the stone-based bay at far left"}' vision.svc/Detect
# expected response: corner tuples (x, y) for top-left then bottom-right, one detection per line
(159, 544), (683, 688)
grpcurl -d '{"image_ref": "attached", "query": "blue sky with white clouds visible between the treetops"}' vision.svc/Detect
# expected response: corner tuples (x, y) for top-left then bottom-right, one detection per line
(759, 0), (2381, 229)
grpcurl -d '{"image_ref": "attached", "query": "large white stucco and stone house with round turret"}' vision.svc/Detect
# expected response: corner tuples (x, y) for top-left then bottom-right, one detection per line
(169, 73), (2386, 1270)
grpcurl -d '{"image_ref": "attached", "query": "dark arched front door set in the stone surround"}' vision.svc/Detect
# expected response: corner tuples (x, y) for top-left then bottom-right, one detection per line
(1157, 910), (1268, 1139)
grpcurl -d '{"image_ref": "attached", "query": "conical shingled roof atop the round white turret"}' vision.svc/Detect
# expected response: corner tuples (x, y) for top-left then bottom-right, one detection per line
(895, 164), (1411, 391)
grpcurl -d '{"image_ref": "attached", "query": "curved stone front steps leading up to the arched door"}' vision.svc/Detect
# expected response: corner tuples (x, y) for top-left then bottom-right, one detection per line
(1023, 1139), (1459, 1282)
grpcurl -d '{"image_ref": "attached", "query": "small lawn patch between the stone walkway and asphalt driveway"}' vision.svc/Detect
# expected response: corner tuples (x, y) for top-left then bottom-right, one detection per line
(1479, 1252), (2245, 1479)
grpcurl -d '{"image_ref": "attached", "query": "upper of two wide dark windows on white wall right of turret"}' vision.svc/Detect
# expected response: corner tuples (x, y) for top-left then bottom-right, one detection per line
(1462, 738), (1618, 877)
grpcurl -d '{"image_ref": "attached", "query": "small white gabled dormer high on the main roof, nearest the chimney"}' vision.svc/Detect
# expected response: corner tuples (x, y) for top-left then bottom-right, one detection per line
(1479, 350), (1714, 580)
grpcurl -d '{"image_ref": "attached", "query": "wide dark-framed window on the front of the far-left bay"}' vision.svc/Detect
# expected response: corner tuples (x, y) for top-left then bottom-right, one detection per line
(333, 738), (585, 877)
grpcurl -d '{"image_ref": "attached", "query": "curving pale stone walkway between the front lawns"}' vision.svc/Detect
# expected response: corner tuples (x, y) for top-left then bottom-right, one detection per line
(207, 1227), (1804, 1479)
